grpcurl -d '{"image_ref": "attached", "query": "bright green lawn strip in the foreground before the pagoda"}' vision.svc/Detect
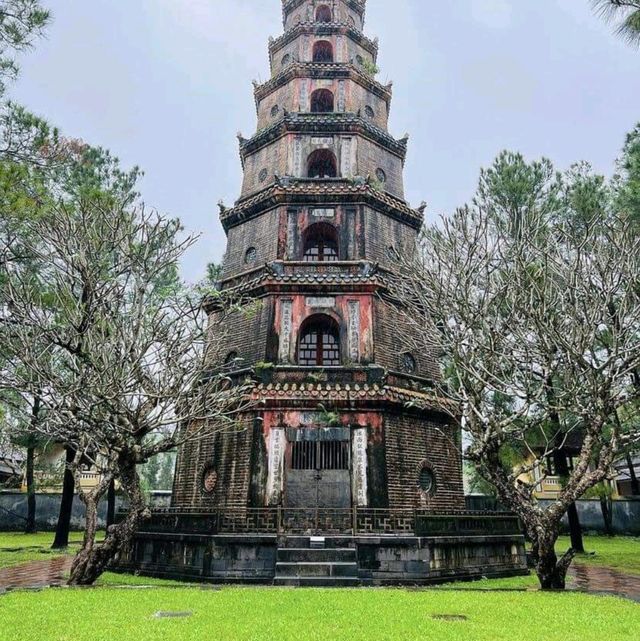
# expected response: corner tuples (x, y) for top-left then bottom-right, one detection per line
(0, 588), (640, 641)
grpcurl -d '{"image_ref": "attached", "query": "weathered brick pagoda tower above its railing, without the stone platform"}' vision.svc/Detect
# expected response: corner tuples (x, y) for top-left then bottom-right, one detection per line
(173, 0), (464, 511)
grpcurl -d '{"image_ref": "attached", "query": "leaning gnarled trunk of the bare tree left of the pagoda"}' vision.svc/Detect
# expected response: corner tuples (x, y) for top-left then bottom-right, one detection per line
(69, 455), (149, 586)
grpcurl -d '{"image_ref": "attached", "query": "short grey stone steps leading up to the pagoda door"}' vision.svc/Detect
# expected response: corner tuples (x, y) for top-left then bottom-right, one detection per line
(274, 537), (360, 587)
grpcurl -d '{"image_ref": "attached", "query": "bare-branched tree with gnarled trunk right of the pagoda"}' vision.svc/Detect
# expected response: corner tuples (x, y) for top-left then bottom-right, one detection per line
(395, 154), (640, 588)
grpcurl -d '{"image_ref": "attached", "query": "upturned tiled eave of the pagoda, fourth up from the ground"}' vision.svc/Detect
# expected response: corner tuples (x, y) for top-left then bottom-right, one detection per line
(238, 111), (409, 164)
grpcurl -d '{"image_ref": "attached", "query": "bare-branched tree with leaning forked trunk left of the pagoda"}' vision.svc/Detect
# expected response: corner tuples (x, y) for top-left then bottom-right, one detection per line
(0, 198), (250, 585)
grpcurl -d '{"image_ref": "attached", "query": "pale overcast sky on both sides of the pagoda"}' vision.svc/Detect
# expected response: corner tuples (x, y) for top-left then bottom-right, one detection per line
(12, 0), (640, 280)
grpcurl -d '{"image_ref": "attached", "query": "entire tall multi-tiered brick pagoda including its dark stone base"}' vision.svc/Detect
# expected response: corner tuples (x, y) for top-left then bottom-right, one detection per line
(122, 0), (523, 582)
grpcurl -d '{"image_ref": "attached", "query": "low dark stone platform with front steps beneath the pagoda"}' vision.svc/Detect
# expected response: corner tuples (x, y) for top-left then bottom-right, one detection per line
(115, 532), (528, 586)
